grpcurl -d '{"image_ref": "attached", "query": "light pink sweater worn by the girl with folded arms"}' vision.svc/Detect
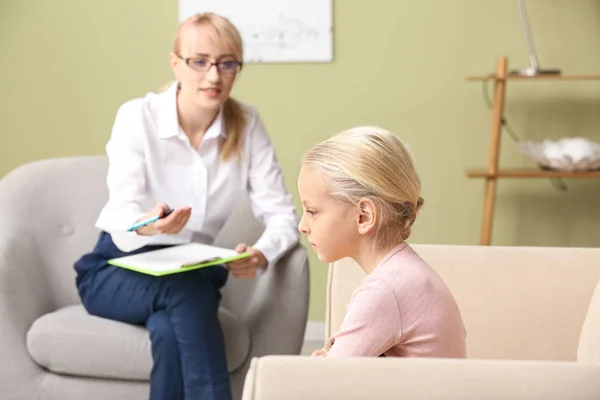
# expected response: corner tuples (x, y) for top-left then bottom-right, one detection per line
(327, 243), (466, 358)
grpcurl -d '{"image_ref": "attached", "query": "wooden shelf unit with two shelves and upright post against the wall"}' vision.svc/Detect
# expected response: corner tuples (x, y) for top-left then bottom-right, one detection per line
(467, 57), (600, 246)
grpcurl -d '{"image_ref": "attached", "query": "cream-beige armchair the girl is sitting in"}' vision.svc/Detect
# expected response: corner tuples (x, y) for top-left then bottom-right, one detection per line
(243, 245), (600, 400)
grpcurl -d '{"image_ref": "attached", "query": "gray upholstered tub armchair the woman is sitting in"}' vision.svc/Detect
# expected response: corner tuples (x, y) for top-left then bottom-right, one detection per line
(0, 156), (309, 400)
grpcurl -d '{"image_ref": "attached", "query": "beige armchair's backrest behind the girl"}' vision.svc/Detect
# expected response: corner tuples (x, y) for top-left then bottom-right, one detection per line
(326, 245), (600, 360)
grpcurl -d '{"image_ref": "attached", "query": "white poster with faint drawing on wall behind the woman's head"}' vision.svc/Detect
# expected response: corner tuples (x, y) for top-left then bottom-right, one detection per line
(179, 0), (333, 63)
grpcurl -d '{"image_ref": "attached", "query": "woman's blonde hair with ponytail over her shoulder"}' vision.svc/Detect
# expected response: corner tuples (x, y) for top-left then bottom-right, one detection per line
(173, 13), (247, 161)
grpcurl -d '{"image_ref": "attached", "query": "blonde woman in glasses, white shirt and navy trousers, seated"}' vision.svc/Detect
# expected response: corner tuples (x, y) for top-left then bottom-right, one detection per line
(75, 14), (298, 400)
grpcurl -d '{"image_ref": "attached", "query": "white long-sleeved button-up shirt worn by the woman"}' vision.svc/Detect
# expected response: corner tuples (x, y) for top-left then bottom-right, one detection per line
(96, 83), (299, 263)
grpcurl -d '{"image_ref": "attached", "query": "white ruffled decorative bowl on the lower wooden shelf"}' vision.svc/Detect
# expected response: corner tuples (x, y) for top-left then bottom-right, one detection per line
(519, 138), (600, 171)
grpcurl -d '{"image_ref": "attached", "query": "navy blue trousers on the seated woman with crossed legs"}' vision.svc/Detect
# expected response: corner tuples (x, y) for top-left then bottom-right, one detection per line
(75, 232), (231, 400)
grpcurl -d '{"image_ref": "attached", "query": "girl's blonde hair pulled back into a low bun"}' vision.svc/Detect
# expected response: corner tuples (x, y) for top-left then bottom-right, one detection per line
(303, 126), (423, 247)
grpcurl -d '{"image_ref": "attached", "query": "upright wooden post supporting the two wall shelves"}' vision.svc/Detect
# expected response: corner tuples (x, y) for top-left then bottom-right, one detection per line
(481, 57), (508, 246)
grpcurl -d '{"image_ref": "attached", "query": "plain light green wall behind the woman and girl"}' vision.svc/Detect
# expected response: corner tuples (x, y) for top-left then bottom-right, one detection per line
(0, 0), (600, 320)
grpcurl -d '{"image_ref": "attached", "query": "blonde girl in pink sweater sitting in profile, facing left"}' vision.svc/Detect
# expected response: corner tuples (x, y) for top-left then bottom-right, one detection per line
(298, 127), (466, 358)
